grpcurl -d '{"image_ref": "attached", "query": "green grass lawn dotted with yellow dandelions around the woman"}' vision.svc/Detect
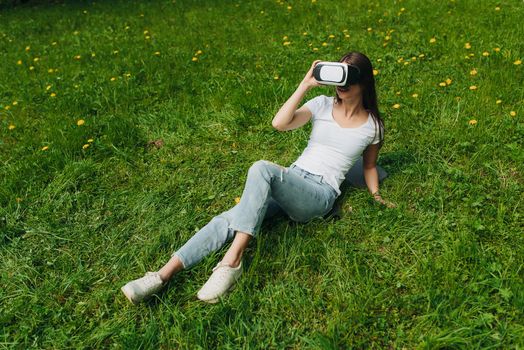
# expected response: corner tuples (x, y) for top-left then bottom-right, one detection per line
(0, 0), (524, 349)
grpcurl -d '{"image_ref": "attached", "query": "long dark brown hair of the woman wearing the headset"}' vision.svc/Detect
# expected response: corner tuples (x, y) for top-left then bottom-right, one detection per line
(335, 51), (385, 144)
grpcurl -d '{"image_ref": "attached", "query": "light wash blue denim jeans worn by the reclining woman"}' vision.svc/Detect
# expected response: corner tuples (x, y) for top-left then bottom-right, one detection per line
(173, 160), (337, 268)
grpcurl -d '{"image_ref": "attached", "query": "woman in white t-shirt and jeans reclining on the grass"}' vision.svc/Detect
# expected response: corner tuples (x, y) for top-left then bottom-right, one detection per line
(122, 52), (393, 303)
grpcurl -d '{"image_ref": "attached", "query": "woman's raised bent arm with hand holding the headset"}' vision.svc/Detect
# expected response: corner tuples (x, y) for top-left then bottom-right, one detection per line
(271, 61), (320, 131)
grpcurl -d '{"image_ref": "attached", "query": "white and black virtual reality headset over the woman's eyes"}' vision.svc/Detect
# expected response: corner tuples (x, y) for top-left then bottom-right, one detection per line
(313, 62), (360, 88)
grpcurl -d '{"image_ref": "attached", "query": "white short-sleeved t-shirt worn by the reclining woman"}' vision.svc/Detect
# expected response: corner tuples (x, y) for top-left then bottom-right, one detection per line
(293, 95), (380, 195)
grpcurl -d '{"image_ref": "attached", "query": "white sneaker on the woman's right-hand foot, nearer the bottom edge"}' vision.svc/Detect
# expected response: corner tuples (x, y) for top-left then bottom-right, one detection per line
(197, 262), (242, 304)
